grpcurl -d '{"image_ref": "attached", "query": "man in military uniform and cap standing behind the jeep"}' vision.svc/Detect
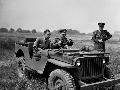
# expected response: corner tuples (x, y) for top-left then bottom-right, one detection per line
(92, 23), (112, 52)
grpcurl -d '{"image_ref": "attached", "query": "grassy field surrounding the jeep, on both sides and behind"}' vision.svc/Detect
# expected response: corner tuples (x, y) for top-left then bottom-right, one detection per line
(0, 33), (120, 90)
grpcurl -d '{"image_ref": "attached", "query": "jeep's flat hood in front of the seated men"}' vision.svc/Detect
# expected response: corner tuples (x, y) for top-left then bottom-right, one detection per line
(50, 49), (109, 65)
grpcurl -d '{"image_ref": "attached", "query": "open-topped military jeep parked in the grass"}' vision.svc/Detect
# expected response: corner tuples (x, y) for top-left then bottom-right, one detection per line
(15, 38), (120, 90)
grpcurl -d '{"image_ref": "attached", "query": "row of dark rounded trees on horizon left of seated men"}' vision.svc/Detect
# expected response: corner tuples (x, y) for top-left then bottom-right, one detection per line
(0, 28), (37, 34)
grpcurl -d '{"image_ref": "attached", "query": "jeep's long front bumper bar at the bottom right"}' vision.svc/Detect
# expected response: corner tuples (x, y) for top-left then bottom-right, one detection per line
(80, 78), (120, 90)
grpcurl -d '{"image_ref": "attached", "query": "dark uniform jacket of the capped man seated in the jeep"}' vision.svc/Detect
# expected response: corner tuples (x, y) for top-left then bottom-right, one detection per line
(52, 38), (73, 49)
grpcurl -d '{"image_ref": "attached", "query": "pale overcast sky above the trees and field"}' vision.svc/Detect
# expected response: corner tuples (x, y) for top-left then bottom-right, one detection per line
(0, 0), (120, 33)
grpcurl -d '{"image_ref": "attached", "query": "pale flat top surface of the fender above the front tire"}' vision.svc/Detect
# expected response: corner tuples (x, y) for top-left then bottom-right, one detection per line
(48, 59), (75, 68)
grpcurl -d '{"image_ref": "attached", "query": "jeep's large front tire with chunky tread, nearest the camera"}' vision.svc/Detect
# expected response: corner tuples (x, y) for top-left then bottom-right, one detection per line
(48, 69), (76, 90)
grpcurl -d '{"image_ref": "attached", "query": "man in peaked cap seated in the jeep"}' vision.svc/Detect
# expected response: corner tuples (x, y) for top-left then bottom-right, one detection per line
(52, 29), (73, 49)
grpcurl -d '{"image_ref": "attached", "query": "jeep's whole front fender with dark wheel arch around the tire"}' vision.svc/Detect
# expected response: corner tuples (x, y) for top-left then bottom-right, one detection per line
(44, 59), (81, 87)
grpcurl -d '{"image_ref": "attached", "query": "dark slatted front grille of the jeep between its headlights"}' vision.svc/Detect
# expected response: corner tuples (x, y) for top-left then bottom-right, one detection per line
(81, 57), (103, 77)
